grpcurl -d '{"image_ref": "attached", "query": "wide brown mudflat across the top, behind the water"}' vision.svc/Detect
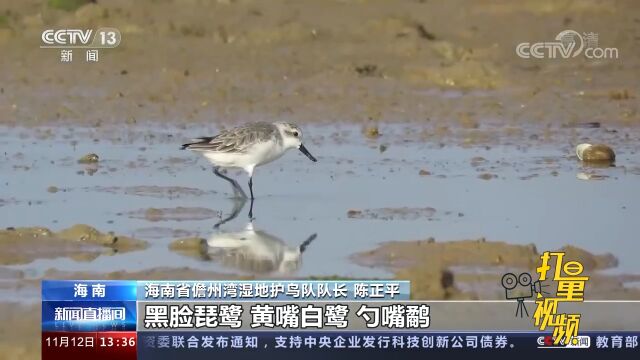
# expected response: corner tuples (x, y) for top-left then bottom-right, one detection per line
(0, 0), (640, 128)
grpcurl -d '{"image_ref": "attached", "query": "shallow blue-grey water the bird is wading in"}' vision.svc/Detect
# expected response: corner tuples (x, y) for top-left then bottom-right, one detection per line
(0, 124), (640, 277)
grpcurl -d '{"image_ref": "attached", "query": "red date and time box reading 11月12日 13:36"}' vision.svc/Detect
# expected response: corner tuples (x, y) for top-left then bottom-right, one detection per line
(42, 331), (138, 360)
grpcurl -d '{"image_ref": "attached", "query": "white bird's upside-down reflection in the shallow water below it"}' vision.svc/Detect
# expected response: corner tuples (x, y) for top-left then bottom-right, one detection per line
(202, 199), (317, 275)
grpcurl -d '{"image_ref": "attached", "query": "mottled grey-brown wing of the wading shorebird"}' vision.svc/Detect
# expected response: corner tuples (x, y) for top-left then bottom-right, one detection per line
(182, 123), (276, 153)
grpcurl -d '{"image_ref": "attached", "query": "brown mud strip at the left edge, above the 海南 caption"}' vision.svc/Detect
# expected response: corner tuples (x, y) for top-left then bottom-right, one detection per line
(0, 225), (147, 265)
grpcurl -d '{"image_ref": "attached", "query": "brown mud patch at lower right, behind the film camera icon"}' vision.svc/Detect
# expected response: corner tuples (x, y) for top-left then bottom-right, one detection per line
(351, 238), (640, 300)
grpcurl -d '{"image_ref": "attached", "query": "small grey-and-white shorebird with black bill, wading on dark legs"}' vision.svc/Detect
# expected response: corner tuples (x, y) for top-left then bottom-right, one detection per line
(182, 122), (317, 217)
